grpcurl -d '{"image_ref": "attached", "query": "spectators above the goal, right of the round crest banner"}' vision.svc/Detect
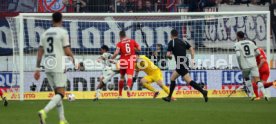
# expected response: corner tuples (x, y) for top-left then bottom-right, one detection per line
(63, 0), (271, 12)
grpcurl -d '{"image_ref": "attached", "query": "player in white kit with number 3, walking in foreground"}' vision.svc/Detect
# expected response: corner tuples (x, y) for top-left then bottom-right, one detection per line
(34, 12), (75, 124)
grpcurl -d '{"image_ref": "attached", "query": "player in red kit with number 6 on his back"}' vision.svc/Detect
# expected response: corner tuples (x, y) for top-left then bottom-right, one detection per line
(111, 31), (141, 97)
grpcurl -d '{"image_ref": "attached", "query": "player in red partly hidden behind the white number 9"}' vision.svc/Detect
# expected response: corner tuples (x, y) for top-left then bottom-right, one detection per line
(253, 41), (276, 100)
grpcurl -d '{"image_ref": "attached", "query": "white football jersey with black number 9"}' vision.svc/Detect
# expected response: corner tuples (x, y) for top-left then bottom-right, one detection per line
(235, 40), (259, 69)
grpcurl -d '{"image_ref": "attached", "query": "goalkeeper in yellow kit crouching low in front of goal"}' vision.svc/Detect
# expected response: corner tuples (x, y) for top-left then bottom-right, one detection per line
(133, 55), (169, 98)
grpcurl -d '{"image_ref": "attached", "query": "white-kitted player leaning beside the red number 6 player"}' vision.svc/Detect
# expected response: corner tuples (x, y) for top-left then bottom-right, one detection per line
(93, 45), (120, 101)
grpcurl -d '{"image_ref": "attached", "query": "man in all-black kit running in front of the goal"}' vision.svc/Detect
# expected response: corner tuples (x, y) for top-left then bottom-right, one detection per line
(163, 29), (208, 102)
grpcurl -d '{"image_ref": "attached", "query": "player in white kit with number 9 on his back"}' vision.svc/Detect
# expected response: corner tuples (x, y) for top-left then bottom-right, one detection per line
(234, 31), (268, 101)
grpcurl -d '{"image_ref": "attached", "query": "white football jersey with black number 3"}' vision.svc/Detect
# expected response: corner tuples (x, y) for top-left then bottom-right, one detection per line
(39, 27), (70, 72)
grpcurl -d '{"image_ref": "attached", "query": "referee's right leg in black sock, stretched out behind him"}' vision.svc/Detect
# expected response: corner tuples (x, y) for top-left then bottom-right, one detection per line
(183, 72), (208, 102)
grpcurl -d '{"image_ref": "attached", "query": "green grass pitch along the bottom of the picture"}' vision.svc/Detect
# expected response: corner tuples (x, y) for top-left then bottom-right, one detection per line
(0, 98), (276, 124)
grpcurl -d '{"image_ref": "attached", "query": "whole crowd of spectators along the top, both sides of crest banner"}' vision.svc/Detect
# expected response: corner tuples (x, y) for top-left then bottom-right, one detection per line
(0, 0), (273, 12)
